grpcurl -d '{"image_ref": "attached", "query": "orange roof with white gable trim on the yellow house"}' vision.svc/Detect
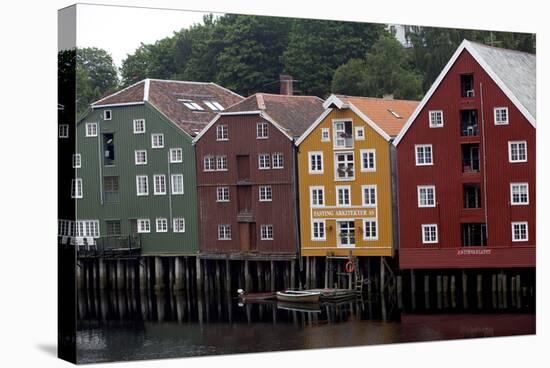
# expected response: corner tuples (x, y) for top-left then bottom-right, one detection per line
(296, 94), (418, 145)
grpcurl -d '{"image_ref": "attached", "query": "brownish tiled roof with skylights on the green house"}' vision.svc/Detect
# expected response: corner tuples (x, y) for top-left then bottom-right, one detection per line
(91, 79), (243, 137)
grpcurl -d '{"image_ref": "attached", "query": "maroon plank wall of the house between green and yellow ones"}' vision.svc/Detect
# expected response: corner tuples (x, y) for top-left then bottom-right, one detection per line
(196, 115), (297, 254)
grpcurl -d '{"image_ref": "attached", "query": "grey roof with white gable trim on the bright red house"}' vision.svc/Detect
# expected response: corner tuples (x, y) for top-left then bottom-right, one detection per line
(394, 40), (537, 145)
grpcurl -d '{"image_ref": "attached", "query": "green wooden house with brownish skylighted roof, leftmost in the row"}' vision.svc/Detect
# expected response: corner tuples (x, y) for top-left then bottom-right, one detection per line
(73, 79), (243, 255)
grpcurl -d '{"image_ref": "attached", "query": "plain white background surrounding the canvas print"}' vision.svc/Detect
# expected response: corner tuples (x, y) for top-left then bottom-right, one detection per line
(0, 0), (550, 368)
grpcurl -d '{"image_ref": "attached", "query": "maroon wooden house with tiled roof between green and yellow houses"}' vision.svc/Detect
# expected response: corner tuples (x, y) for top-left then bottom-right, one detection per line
(194, 93), (323, 260)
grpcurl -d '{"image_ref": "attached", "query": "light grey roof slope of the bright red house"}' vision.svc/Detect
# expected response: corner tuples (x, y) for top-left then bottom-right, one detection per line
(469, 41), (537, 119)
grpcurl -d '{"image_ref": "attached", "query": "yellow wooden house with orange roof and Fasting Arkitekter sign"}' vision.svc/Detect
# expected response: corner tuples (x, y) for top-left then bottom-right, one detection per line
(296, 95), (418, 256)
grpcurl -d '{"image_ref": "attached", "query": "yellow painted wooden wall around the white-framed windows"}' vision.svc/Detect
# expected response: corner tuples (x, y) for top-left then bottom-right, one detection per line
(298, 109), (393, 256)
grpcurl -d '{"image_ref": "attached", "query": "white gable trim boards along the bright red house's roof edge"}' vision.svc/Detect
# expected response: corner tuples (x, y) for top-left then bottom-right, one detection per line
(393, 40), (536, 147)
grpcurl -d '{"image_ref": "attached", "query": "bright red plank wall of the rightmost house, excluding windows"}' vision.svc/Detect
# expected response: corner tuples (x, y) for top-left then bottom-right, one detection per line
(397, 50), (536, 268)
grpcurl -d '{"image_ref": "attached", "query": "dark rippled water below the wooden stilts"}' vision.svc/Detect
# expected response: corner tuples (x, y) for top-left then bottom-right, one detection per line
(77, 292), (535, 363)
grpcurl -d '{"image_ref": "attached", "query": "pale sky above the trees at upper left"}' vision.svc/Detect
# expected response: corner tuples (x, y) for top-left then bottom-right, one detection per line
(76, 4), (218, 67)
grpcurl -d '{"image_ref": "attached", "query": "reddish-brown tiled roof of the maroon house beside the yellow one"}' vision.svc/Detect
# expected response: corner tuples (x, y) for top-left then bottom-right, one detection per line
(224, 93), (324, 138)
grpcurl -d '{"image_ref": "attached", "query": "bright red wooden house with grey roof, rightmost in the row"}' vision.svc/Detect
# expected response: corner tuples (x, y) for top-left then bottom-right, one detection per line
(394, 40), (536, 269)
